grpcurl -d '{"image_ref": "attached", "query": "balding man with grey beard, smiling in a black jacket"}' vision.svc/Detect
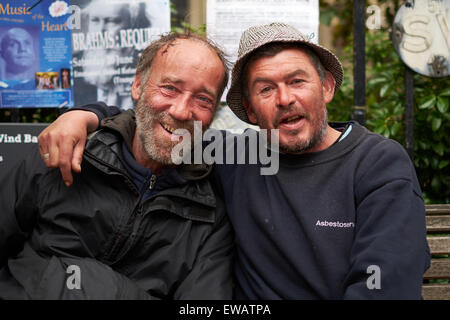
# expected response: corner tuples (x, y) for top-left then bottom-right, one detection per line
(0, 34), (233, 299)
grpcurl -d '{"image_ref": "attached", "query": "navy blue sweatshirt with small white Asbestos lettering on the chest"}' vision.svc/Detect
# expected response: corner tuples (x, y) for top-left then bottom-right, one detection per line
(77, 105), (430, 299)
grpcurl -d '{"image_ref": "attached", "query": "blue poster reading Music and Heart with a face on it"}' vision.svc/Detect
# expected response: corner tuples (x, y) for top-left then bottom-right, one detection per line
(0, 0), (73, 108)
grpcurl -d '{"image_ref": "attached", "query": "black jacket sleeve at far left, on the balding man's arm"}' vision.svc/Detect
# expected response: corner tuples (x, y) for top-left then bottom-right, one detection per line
(0, 150), (156, 300)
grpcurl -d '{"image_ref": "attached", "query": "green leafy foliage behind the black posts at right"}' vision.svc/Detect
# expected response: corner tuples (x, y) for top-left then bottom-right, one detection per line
(321, 0), (450, 203)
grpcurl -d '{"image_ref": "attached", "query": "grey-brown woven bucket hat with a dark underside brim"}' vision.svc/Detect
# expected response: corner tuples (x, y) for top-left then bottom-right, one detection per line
(227, 22), (344, 123)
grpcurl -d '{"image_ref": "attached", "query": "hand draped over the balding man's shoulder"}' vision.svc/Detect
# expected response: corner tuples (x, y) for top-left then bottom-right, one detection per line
(38, 110), (98, 187)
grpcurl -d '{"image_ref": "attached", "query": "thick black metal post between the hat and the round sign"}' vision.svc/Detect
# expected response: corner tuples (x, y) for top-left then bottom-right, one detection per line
(353, 0), (366, 125)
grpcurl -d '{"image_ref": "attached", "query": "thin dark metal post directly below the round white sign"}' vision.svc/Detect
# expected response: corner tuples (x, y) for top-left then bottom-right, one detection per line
(405, 65), (414, 160)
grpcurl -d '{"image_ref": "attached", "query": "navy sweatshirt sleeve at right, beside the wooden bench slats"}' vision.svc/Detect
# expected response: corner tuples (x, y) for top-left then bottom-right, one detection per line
(344, 140), (430, 299)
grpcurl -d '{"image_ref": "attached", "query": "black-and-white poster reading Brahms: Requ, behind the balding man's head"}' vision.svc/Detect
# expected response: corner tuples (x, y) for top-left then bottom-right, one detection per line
(71, 0), (170, 109)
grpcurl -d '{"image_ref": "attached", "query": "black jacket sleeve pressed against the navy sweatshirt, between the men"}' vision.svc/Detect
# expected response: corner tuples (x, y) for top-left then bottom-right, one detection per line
(174, 202), (234, 300)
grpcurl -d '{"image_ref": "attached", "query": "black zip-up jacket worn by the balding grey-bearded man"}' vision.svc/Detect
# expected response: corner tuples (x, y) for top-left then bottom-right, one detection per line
(0, 111), (233, 299)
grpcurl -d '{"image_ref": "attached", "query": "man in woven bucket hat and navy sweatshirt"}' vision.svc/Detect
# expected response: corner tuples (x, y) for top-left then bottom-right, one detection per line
(35, 23), (430, 299)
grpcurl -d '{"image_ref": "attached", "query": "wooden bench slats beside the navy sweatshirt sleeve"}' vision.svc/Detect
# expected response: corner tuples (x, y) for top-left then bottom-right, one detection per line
(422, 204), (450, 300)
